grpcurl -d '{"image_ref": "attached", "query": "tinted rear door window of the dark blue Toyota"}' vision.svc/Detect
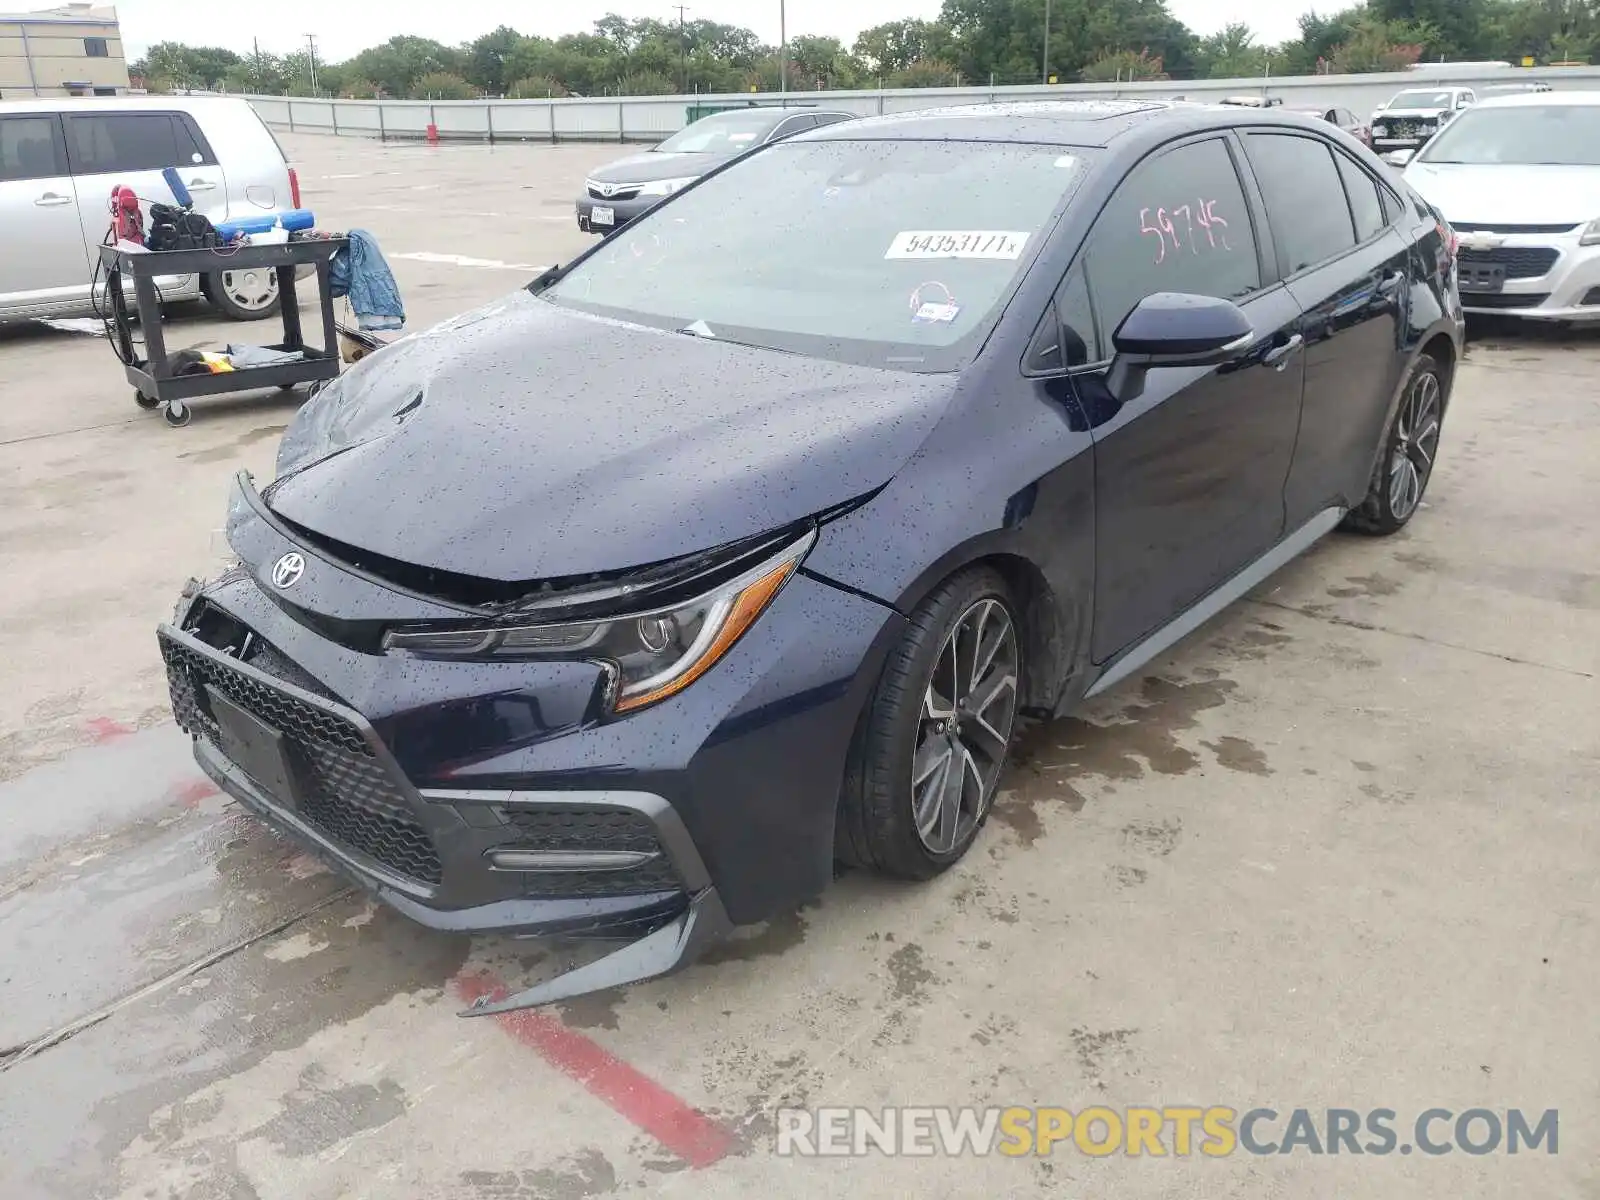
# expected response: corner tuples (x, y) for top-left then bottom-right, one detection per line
(1246, 133), (1355, 275)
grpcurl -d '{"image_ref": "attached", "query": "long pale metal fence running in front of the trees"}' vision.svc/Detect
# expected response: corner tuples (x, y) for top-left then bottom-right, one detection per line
(248, 67), (1600, 142)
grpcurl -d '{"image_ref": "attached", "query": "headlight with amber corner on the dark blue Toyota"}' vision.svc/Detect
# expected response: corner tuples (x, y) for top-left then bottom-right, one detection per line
(384, 531), (816, 712)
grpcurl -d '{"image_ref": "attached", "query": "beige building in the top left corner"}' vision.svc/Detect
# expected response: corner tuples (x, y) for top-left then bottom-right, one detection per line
(0, 3), (128, 99)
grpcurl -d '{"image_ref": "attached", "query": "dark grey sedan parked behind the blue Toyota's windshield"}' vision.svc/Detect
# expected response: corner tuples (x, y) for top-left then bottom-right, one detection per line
(578, 106), (854, 234)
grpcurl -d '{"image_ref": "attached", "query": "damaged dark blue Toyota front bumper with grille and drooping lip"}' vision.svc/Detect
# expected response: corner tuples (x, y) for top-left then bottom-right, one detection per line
(158, 482), (901, 1013)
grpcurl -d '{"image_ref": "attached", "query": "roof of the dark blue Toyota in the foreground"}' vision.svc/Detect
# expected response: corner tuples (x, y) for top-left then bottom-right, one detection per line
(800, 99), (1326, 147)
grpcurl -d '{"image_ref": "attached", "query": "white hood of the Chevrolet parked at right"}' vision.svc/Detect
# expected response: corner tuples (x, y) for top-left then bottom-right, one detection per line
(1405, 162), (1600, 226)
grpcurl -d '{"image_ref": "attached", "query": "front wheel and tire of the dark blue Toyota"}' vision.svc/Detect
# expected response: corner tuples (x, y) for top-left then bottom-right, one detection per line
(837, 568), (1022, 880)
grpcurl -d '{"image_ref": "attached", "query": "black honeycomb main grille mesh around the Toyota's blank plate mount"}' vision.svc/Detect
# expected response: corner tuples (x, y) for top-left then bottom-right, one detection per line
(160, 635), (443, 883)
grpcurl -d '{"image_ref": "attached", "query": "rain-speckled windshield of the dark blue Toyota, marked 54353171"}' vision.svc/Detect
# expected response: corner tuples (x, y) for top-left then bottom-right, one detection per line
(542, 141), (1083, 371)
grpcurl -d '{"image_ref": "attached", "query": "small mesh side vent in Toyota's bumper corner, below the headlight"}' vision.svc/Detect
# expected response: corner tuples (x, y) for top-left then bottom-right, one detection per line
(501, 806), (683, 898)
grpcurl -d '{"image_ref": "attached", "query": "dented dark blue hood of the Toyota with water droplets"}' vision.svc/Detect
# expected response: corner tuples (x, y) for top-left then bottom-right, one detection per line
(266, 291), (954, 581)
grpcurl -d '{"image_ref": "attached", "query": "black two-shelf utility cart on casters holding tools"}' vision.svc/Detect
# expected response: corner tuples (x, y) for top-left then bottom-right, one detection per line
(101, 237), (349, 426)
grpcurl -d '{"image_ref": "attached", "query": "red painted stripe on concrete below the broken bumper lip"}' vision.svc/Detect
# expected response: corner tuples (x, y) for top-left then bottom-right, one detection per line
(454, 971), (736, 1170)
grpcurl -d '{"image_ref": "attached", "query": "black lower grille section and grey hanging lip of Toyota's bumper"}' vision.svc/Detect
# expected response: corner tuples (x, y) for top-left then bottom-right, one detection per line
(157, 626), (733, 1014)
